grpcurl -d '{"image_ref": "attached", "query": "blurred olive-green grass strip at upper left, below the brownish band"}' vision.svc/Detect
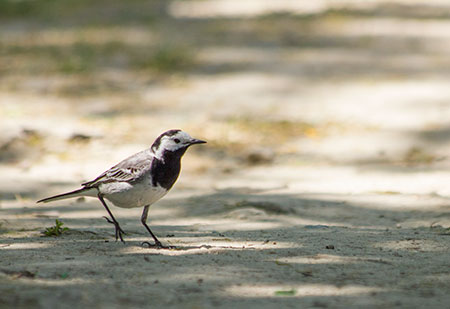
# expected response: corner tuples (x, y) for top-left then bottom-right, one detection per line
(0, 41), (195, 74)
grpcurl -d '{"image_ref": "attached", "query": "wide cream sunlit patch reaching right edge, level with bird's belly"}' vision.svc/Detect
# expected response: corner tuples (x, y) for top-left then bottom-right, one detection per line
(230, 164), (448, 200)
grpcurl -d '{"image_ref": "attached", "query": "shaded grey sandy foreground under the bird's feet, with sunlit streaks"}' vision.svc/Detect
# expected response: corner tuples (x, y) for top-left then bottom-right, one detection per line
(0, 185), (450, 307)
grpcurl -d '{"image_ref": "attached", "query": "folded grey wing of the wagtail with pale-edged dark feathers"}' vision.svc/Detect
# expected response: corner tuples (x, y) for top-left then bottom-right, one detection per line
(82, 150), (153, 188)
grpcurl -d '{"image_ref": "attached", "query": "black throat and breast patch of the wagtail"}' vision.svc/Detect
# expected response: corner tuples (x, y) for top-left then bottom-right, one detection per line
(151, 147), (187, 190)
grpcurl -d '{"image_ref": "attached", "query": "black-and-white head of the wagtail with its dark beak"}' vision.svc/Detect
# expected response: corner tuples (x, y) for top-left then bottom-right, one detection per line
(151, 130), (206, 158)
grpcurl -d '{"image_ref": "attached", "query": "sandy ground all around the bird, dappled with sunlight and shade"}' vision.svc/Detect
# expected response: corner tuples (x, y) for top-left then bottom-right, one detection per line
(0, 1), (450, 308)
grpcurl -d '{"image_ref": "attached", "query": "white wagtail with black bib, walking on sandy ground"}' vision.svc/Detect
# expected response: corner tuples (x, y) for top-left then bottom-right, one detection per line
(38, 130), (206, 248)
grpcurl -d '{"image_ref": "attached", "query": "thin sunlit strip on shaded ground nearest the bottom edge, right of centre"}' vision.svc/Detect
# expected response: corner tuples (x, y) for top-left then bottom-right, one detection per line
(226, 284), (382, 298)
